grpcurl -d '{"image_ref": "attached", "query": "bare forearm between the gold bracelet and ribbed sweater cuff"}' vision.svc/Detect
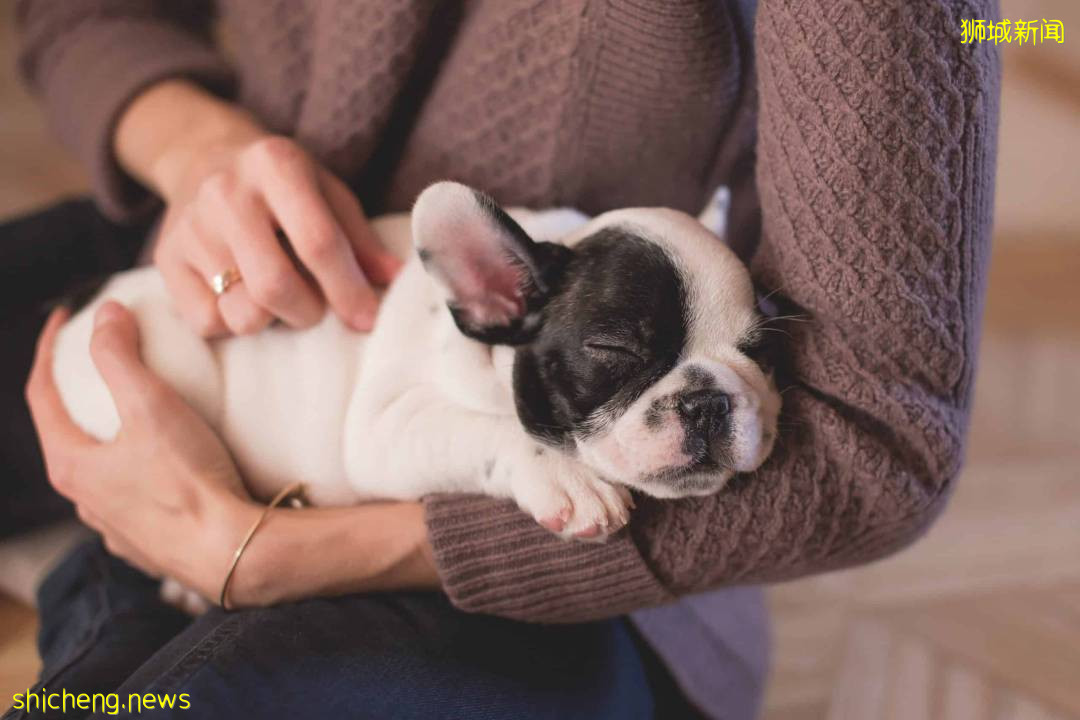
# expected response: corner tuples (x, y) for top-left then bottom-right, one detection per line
(223, 503), (440, 607)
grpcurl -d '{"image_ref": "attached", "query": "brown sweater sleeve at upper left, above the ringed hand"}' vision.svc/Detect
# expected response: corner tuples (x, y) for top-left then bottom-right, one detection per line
(16, 0), (231, 219)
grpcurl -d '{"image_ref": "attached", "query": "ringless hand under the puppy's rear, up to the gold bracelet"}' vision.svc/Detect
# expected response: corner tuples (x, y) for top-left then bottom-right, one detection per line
(26, 303), (259, 597)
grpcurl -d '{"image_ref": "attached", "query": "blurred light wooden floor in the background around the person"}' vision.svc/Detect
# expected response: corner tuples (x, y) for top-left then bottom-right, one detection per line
(0, 0), (1080, 720)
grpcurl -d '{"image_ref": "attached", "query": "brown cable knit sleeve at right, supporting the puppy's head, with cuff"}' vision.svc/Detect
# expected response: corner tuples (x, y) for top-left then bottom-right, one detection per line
(427, 0), (999, 621)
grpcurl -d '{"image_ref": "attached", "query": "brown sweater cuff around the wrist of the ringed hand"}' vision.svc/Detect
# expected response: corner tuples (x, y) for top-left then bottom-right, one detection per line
(41, 17), (232, 220)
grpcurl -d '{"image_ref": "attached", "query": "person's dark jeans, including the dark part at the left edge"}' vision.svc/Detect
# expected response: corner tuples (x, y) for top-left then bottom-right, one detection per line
(0, 201), (690, 720)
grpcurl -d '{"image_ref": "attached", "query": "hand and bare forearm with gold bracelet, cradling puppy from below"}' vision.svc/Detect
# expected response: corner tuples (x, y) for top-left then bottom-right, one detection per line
(26, 303), (438, 607)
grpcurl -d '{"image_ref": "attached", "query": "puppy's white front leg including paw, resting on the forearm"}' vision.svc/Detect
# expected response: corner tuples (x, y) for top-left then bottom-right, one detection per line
(346, 386), (632, 539)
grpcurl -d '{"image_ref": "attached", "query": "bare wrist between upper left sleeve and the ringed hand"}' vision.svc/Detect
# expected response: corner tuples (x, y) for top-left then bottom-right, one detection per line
(113, 80), (267, 199)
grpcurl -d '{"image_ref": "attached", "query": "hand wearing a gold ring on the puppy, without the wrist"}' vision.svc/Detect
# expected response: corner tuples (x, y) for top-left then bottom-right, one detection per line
(154, 137), (388, 337)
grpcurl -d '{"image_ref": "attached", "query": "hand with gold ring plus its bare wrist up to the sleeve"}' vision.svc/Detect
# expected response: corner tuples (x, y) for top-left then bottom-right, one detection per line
(116, 80), (401, 336)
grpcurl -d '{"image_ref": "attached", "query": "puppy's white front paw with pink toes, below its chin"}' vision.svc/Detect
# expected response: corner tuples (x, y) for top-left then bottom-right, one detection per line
(514, 450), (634, 542)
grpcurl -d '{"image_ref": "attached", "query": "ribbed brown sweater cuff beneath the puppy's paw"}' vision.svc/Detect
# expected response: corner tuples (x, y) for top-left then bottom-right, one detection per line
(424, 495), (674, 623)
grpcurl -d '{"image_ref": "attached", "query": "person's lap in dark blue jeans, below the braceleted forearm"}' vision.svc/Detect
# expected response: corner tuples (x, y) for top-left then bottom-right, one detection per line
(15, 541), (653, 719)
